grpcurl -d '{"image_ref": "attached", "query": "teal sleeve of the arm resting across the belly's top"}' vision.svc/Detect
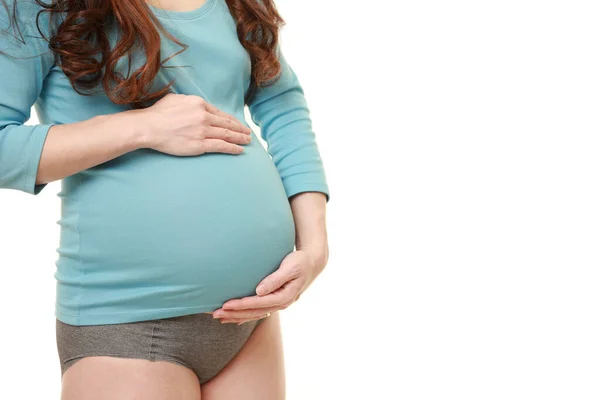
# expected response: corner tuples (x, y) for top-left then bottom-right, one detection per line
(0, 2), (53, 195)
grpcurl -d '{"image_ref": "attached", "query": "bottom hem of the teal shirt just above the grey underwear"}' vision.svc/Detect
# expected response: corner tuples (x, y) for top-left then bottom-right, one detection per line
(54, 304), (222, 326)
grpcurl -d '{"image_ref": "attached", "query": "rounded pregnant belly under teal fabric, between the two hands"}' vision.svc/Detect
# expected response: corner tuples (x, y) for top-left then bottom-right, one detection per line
(57, 141), (295, 313)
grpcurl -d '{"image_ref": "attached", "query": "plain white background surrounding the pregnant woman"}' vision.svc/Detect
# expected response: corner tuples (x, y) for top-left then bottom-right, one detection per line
(0, 0), (600, 400)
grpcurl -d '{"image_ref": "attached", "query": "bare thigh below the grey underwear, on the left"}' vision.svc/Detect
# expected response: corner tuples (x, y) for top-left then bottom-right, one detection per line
(61, 356), (200, 400)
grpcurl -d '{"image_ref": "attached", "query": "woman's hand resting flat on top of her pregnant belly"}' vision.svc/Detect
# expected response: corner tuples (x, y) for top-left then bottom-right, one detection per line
(140, 93), (252, 156)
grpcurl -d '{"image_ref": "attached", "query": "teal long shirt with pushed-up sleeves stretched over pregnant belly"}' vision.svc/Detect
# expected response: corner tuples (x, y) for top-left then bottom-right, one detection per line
(0, 0), (329, 325)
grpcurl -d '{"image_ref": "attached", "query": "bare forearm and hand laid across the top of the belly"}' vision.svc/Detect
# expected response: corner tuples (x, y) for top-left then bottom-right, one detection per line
(36, 94), (251, 189)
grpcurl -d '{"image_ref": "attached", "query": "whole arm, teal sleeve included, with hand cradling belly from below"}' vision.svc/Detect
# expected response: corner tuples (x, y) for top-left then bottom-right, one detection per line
(200, 44), (329, 323)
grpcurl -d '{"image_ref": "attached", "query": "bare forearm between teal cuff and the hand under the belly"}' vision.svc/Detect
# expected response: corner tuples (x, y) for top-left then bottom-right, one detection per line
(290, 192), (329, 266)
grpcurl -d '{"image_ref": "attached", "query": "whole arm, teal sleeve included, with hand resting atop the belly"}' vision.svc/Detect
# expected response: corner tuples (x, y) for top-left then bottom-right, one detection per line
(0, 2), (251, 195)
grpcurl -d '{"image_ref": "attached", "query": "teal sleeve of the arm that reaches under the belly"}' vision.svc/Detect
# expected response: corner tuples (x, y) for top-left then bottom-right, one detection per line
(248, 45), (329, 202)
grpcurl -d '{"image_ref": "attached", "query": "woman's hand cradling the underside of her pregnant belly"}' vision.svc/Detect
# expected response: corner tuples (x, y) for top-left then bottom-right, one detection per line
(213, 249), (327, 325)
